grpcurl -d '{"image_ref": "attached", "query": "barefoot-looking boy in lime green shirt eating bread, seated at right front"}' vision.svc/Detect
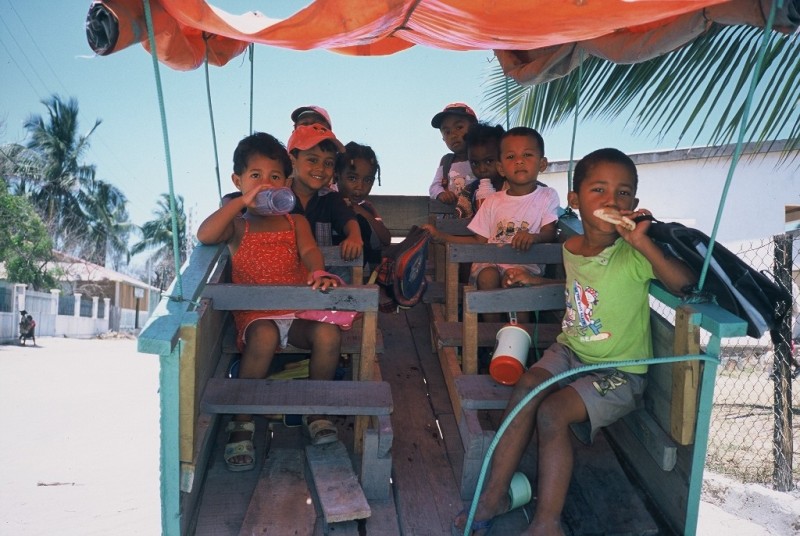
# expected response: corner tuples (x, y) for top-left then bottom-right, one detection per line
(453, 149), (695, 536)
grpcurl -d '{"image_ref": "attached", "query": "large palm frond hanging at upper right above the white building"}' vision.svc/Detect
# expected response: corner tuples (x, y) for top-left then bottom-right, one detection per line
(485, 24), (800, 157)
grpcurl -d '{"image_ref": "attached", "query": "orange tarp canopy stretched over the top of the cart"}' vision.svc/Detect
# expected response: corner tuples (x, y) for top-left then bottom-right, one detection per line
(87, 0), (792, 83)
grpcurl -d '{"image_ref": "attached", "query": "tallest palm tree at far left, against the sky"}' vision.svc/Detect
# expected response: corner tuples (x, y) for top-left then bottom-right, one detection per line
(24, 95), (101, 243)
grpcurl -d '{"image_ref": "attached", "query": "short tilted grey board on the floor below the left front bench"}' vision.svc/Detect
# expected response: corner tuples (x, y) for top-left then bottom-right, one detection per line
(306, 441), (372, 533)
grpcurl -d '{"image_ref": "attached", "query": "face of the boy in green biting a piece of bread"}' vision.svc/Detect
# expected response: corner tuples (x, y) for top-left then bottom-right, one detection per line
(568, 162), (639, 230)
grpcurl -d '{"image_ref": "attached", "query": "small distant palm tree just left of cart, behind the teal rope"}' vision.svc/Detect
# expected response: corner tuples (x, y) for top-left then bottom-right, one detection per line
(131, 194), (188, 290)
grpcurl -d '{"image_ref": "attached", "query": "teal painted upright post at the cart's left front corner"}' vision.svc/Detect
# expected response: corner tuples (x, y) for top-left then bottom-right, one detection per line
(158, 341), (183, 536)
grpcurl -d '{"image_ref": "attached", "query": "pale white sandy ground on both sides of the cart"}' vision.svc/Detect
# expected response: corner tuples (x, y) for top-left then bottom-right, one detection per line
(0, 337), (800, 536)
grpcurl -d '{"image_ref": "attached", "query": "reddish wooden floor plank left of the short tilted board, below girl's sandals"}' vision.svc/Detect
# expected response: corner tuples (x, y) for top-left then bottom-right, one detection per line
(239, 449), (316, 536)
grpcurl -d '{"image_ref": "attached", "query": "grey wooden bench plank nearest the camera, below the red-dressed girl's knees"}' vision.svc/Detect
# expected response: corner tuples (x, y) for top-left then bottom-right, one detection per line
(201, 378), (392, 415)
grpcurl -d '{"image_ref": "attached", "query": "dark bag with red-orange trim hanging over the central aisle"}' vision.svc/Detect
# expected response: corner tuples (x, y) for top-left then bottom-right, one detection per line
(370, 225), (431, 311)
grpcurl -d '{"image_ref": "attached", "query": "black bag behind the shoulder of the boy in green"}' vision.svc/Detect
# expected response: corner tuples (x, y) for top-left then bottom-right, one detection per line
(647, 221), (792, 338)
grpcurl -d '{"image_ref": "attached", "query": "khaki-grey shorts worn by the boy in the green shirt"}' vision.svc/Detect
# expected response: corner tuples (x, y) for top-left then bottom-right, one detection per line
(531, 342), (647, 444)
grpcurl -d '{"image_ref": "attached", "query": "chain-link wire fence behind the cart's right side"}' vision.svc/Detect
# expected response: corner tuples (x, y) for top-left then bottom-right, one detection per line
(706, 231), (800, 491)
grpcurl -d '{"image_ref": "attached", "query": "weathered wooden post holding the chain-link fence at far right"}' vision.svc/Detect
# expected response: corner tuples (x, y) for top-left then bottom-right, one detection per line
(772, 234), (794, 491)
